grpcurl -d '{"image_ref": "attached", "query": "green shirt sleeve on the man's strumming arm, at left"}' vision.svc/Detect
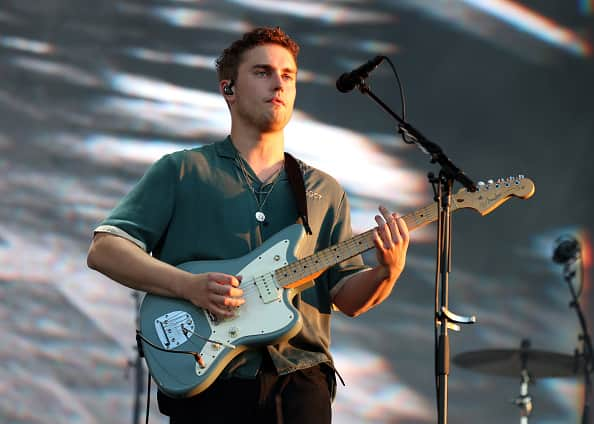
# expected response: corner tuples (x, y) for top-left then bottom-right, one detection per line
(95, 155), (178, 252)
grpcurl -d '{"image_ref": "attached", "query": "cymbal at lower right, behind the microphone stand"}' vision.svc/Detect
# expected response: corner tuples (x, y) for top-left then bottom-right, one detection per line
(453, 349), (582, 378)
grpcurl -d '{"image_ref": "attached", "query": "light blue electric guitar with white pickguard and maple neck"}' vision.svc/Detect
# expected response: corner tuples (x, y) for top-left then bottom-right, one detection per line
(138, 176), (534, 398)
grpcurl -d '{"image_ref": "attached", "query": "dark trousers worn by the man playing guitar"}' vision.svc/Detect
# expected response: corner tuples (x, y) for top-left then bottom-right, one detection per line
(159, 364), (334, 424)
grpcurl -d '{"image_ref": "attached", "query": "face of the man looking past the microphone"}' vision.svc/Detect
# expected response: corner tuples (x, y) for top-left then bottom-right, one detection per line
(227, 44), (297, 132)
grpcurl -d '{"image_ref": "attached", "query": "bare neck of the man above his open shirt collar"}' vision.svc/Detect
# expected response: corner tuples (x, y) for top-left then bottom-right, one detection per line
(231, 128), (285, 181)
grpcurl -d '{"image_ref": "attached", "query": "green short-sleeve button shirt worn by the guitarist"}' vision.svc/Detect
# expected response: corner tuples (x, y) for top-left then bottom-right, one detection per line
(96, 137), (365, 378)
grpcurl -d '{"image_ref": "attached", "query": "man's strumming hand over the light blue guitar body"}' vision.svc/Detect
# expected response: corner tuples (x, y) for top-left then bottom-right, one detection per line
(183, 272), (245, 319)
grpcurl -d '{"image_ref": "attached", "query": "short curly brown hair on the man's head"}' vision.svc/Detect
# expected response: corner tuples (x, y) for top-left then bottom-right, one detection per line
(215, 27), (299, 81)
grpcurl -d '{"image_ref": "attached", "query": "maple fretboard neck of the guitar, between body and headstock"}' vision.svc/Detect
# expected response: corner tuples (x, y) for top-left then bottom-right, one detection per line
(275, 203), (440, 288)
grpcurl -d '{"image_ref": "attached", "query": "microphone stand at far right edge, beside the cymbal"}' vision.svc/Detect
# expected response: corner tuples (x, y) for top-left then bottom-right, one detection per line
(563, 262), (594, 424)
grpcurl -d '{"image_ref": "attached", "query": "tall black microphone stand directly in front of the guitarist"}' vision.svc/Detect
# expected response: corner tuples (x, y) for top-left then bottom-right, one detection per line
(357, 78), (477, 424)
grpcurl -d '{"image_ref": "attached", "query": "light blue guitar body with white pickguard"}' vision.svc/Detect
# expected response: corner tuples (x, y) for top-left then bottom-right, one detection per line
(140, 224), (313, 398)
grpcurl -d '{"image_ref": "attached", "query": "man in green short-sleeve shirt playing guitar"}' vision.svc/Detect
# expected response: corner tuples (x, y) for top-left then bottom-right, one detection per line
(88, 28), (409, 424)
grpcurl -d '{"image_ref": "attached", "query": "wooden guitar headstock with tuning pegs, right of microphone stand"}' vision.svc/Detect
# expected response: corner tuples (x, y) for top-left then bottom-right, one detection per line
(452, 175), (535, 215)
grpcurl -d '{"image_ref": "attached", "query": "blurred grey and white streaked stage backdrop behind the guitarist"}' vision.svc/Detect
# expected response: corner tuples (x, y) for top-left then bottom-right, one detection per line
(0, 0), (594, 424)
